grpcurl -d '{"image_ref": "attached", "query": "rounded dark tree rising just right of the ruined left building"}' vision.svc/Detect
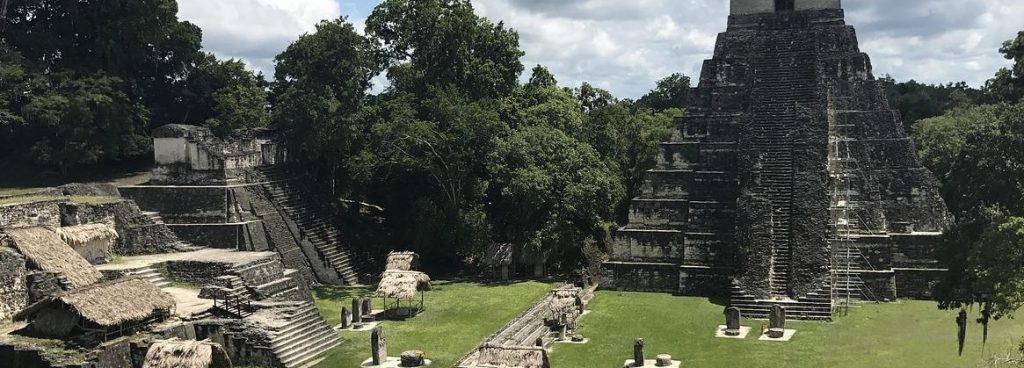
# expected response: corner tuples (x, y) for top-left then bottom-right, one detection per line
(272, 17), (377, 173)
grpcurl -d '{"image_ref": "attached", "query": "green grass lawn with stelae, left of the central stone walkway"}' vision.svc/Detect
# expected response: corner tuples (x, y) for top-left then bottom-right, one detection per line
(313, 282), (553, 368)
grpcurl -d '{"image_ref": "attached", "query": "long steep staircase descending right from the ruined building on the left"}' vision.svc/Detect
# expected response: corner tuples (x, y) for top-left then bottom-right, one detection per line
(261, 167), (359, 285)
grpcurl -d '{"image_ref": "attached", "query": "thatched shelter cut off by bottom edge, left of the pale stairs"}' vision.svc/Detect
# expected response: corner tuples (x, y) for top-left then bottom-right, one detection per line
(142, 338), (231, 368)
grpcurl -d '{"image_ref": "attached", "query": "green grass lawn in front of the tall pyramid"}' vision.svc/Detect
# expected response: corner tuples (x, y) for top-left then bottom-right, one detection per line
(551, 291), (1024, 368)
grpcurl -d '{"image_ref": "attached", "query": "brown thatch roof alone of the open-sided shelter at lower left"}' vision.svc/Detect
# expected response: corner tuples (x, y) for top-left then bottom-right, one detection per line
(15, 277), (175, 327)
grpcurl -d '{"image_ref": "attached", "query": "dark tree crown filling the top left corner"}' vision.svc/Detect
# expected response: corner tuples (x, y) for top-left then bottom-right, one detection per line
(4, 0), (203, 122)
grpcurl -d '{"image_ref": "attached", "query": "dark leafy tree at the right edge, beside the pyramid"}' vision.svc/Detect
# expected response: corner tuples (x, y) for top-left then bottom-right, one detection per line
(929, 101), (1024, 318)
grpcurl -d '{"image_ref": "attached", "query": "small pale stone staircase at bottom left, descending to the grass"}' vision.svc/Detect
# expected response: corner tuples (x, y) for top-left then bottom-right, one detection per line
(270, 302), (341, 368)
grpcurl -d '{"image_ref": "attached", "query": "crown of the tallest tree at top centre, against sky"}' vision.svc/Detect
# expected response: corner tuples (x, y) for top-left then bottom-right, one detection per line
(367, 0), (523, 98)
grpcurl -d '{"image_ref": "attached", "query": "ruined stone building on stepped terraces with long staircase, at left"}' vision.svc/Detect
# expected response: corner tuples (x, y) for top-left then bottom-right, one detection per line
(119, 125), (359, 285)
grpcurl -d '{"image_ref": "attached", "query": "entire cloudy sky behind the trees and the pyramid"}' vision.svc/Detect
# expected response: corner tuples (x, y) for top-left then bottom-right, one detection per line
(178, 0), (1024, 97)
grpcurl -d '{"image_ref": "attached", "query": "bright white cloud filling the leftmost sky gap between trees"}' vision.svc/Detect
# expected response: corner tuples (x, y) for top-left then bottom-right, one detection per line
(178, 0), (341, 76)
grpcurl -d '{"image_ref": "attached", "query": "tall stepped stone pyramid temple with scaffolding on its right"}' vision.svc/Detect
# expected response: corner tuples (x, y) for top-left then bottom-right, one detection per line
(602, 0), (950, 319)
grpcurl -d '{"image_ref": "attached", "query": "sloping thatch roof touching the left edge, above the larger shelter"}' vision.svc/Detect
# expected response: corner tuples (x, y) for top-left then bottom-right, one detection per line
(4, 228), (103, 288)
